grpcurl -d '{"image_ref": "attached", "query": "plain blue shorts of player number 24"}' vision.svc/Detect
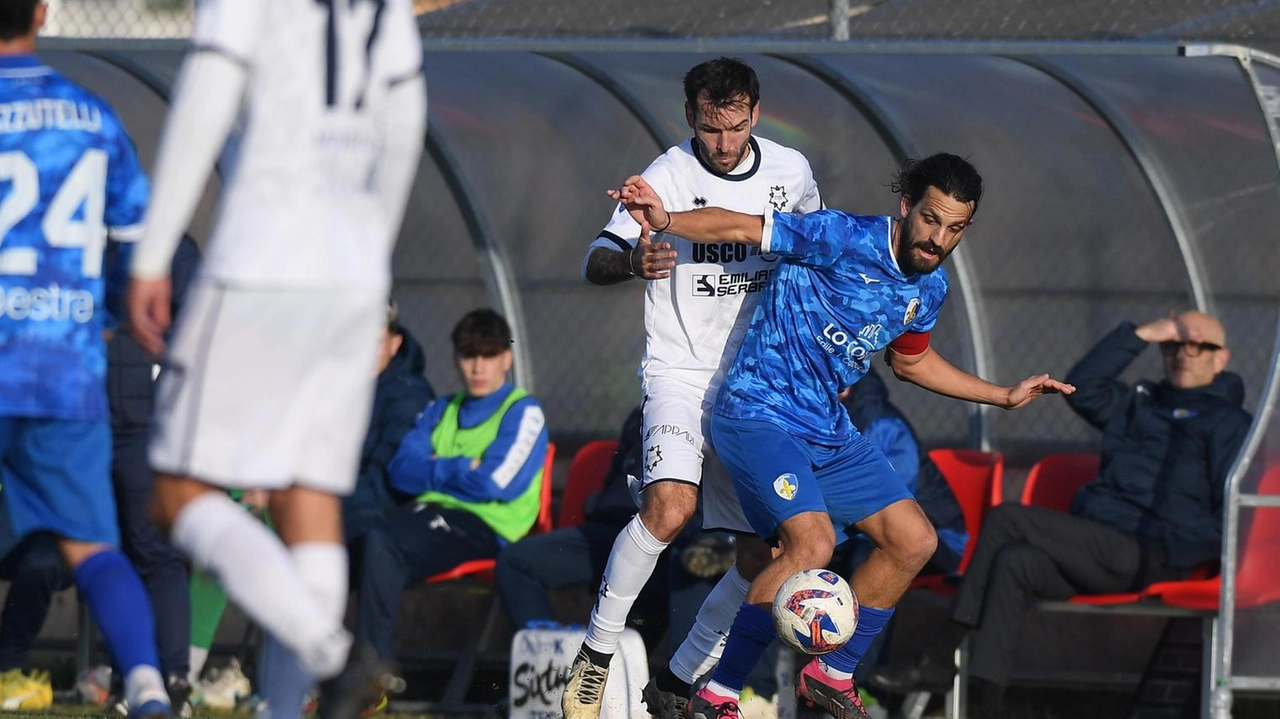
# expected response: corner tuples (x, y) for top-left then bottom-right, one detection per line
(0, 417), (120, 546)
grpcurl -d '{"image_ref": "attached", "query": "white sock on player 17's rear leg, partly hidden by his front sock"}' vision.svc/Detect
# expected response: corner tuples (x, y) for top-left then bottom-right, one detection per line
(262, 542), (347, 719)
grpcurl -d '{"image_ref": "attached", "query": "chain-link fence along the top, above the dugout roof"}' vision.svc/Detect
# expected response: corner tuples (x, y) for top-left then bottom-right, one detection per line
(46, 0), (1280, 49)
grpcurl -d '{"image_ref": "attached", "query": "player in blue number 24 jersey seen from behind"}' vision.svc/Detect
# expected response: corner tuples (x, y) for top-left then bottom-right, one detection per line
(0, 0), (170, 718)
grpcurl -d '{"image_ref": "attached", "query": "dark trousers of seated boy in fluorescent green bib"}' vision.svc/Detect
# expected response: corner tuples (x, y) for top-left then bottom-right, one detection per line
(356, 504), (499, 659)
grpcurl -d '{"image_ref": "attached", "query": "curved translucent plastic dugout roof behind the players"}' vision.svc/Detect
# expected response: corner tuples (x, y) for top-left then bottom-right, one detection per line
(55, 49), (1280, 454)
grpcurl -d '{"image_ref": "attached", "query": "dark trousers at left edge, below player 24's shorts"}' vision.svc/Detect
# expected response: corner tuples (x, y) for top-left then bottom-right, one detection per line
(0, 516), (72, 672)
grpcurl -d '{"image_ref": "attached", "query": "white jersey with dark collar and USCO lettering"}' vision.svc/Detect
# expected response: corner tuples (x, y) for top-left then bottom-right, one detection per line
(591, 137), (822, 399)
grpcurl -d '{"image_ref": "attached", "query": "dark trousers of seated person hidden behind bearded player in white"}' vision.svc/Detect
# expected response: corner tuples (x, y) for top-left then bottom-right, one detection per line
(495, 522), (670, 649)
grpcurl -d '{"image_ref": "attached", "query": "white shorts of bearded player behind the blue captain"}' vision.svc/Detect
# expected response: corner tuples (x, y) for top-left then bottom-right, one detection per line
(641, 379), (754, 533)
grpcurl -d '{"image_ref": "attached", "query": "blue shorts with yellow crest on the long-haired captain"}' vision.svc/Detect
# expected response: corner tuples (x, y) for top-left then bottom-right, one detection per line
(712, 415), (914, 544)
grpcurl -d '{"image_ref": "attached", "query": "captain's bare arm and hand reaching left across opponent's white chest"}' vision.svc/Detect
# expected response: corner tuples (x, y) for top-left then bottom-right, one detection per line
(608, 175), (764, 244)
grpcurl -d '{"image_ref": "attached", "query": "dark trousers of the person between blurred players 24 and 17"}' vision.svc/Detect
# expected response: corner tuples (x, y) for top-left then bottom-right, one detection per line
(111, 431), (191, 677)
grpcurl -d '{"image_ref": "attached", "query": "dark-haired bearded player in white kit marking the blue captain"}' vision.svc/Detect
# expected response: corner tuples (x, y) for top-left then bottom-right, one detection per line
(562, 58), (822, 719)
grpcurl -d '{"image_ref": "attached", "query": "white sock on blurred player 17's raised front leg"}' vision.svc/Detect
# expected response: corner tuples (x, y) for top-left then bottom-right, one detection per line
(173, 491), (351, 678)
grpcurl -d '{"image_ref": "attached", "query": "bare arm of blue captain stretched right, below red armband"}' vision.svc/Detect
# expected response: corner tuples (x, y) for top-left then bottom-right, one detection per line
(888, 347), (1075, 409)
